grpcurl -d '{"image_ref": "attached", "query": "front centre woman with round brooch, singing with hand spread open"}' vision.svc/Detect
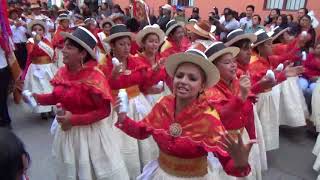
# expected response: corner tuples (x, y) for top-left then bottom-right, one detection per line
(116, 50), (253, 180)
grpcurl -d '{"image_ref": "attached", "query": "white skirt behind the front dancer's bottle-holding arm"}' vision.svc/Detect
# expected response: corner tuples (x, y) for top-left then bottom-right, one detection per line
(112, 93), (159, 179)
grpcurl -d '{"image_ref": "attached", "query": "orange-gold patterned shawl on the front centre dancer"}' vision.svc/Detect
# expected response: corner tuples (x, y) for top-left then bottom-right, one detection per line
(144, 95), (228, 155)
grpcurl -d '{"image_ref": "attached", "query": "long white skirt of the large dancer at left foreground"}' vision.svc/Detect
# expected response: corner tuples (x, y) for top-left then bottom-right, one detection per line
(52, 118), (129, 180)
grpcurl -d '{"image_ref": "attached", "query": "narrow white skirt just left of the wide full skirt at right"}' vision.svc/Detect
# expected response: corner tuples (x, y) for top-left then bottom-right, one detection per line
(256, 89), (280, 151)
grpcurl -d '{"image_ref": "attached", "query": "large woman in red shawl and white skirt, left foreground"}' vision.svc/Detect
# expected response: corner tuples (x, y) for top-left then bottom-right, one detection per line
(29, 27), (129, 180)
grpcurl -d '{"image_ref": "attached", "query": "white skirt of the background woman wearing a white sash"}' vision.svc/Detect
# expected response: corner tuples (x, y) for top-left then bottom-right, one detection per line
(23, 63), (57, 113)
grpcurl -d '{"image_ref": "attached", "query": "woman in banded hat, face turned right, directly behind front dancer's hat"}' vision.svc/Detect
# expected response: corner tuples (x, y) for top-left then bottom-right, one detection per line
(160, 20), (191, 58)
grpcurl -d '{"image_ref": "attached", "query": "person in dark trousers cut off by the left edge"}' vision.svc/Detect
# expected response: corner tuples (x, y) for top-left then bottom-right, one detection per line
(0, 27), (11, 129)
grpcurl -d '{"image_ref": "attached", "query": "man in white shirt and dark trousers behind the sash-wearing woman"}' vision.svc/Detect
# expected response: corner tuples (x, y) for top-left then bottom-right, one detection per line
(9, 8), (28, 69)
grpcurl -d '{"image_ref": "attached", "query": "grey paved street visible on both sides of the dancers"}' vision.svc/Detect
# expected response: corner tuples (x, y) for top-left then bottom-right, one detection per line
(9, 95), (317, 180)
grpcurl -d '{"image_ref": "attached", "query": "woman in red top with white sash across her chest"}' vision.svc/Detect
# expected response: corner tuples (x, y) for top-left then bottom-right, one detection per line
(22, 20), (57, 119)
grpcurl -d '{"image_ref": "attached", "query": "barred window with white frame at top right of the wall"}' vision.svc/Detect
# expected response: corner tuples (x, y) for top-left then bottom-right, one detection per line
(265, 0), (306, 10)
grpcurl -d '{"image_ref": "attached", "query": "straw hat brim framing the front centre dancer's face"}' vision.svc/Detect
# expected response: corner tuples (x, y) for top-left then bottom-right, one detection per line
(165, 52), (220, 88)
